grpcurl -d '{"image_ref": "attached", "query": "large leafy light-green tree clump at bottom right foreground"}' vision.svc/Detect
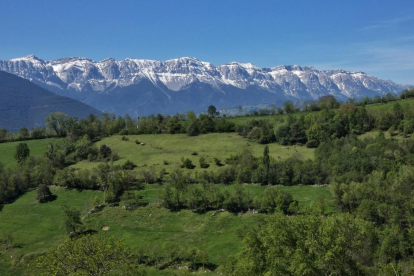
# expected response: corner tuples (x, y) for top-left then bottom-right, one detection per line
(227, 212), (374, 275)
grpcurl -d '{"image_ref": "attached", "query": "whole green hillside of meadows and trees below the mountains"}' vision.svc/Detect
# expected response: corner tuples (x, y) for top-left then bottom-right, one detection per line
(0, 93), (414, 276)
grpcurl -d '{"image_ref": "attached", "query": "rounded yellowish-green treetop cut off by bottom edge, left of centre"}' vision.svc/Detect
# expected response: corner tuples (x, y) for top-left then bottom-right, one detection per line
(37, 234), (146, 276)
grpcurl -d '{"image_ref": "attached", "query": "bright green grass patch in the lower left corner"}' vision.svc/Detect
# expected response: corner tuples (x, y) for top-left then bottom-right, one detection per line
(0, 188), (101, 275)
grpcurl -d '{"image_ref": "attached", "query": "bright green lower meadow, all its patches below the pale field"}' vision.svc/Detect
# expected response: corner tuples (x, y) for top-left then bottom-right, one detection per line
(0, 185), (333, 275)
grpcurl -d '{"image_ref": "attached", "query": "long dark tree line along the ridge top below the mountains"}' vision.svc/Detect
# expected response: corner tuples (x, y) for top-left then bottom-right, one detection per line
(0, 89), (414, 143)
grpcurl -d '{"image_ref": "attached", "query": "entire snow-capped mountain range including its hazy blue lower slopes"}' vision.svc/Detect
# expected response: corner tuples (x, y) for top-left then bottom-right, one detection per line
(0, 55), (406, 115)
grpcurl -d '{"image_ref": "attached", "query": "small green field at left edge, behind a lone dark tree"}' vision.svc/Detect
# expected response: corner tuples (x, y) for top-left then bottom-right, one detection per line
(0, 138), (59, 168)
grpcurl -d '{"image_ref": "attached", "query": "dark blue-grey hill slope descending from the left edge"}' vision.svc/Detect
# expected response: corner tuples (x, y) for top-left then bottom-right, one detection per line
(0, 71), (101, 131)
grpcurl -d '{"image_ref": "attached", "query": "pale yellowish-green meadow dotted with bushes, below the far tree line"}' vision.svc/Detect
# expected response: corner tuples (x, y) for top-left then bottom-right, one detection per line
(74, 133), (314, 171)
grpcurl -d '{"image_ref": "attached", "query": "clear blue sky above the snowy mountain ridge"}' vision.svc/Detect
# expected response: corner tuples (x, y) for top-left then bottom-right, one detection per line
(0, 0), (414, 84)
